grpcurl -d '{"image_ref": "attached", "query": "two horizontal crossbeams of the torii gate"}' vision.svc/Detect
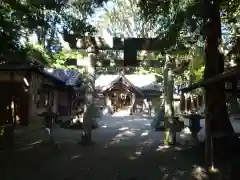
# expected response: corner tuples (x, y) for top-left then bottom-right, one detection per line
(64, 34), (163, 67)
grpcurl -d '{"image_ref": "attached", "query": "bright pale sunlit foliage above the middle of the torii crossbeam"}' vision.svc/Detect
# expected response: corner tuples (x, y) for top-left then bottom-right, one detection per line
(98, 0), (154, 37)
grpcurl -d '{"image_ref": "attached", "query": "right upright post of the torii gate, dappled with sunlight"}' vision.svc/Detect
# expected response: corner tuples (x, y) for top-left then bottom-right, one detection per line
(164, 55), (176, 144)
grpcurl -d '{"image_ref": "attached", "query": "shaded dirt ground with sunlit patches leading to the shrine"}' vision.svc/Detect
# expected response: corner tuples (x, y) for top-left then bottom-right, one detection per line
(0, 113), (236, 180)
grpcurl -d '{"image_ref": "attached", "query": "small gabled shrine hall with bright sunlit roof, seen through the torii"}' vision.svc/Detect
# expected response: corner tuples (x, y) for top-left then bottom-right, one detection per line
(96, 74), (162, 112)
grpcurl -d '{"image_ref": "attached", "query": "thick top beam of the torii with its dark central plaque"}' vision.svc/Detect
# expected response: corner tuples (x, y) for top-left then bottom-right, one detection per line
(68, 37), (165, 67)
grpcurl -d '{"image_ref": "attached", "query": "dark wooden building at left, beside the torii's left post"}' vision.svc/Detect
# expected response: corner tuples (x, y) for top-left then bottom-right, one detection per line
(0, 64), (83, 125)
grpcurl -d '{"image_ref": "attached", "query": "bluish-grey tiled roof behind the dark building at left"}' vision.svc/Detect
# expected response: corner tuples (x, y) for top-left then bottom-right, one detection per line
(44, 68), (80, 86)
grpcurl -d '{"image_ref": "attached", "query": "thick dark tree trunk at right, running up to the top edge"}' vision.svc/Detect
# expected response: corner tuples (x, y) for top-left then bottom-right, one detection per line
(204, 0), (238, 165)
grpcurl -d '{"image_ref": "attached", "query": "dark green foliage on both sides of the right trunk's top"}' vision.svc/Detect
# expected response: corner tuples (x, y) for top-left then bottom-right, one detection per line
(139, 0), (240, 51)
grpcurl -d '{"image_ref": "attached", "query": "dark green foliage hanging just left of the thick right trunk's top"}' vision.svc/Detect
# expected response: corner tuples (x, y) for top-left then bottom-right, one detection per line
(139, 0), (200, 54)
